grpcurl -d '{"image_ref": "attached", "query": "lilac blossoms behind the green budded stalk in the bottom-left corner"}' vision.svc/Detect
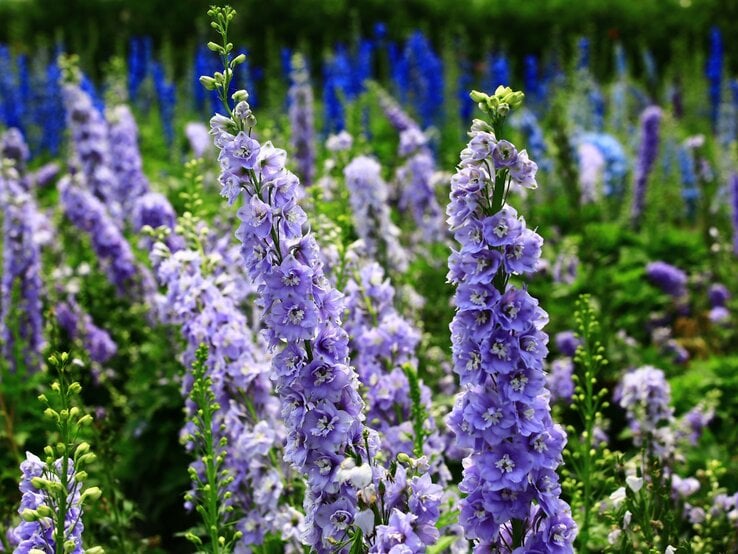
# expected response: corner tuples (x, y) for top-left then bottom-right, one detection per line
(10, 452), (84, 554)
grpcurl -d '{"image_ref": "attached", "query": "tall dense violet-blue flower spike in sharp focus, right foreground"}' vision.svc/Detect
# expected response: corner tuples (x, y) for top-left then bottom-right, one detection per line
(447, 87), (576, 552)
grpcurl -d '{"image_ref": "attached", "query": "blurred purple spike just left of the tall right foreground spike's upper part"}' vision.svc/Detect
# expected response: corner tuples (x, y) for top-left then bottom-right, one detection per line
(395, 127), (443, 242)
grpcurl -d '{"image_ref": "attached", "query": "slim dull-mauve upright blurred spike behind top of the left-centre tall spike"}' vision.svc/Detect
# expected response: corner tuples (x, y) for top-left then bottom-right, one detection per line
(288, 54), (315, 186)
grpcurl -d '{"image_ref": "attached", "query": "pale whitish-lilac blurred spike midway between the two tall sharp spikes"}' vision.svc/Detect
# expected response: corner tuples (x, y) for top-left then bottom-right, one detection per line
(343, 156), (408, 271)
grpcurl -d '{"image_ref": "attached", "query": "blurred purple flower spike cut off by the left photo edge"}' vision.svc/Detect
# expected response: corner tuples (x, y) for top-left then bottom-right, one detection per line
(0, 153), (45, 372)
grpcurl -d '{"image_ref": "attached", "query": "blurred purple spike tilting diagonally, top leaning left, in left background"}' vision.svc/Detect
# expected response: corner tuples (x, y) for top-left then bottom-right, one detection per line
(59, 177), (137, 294)
